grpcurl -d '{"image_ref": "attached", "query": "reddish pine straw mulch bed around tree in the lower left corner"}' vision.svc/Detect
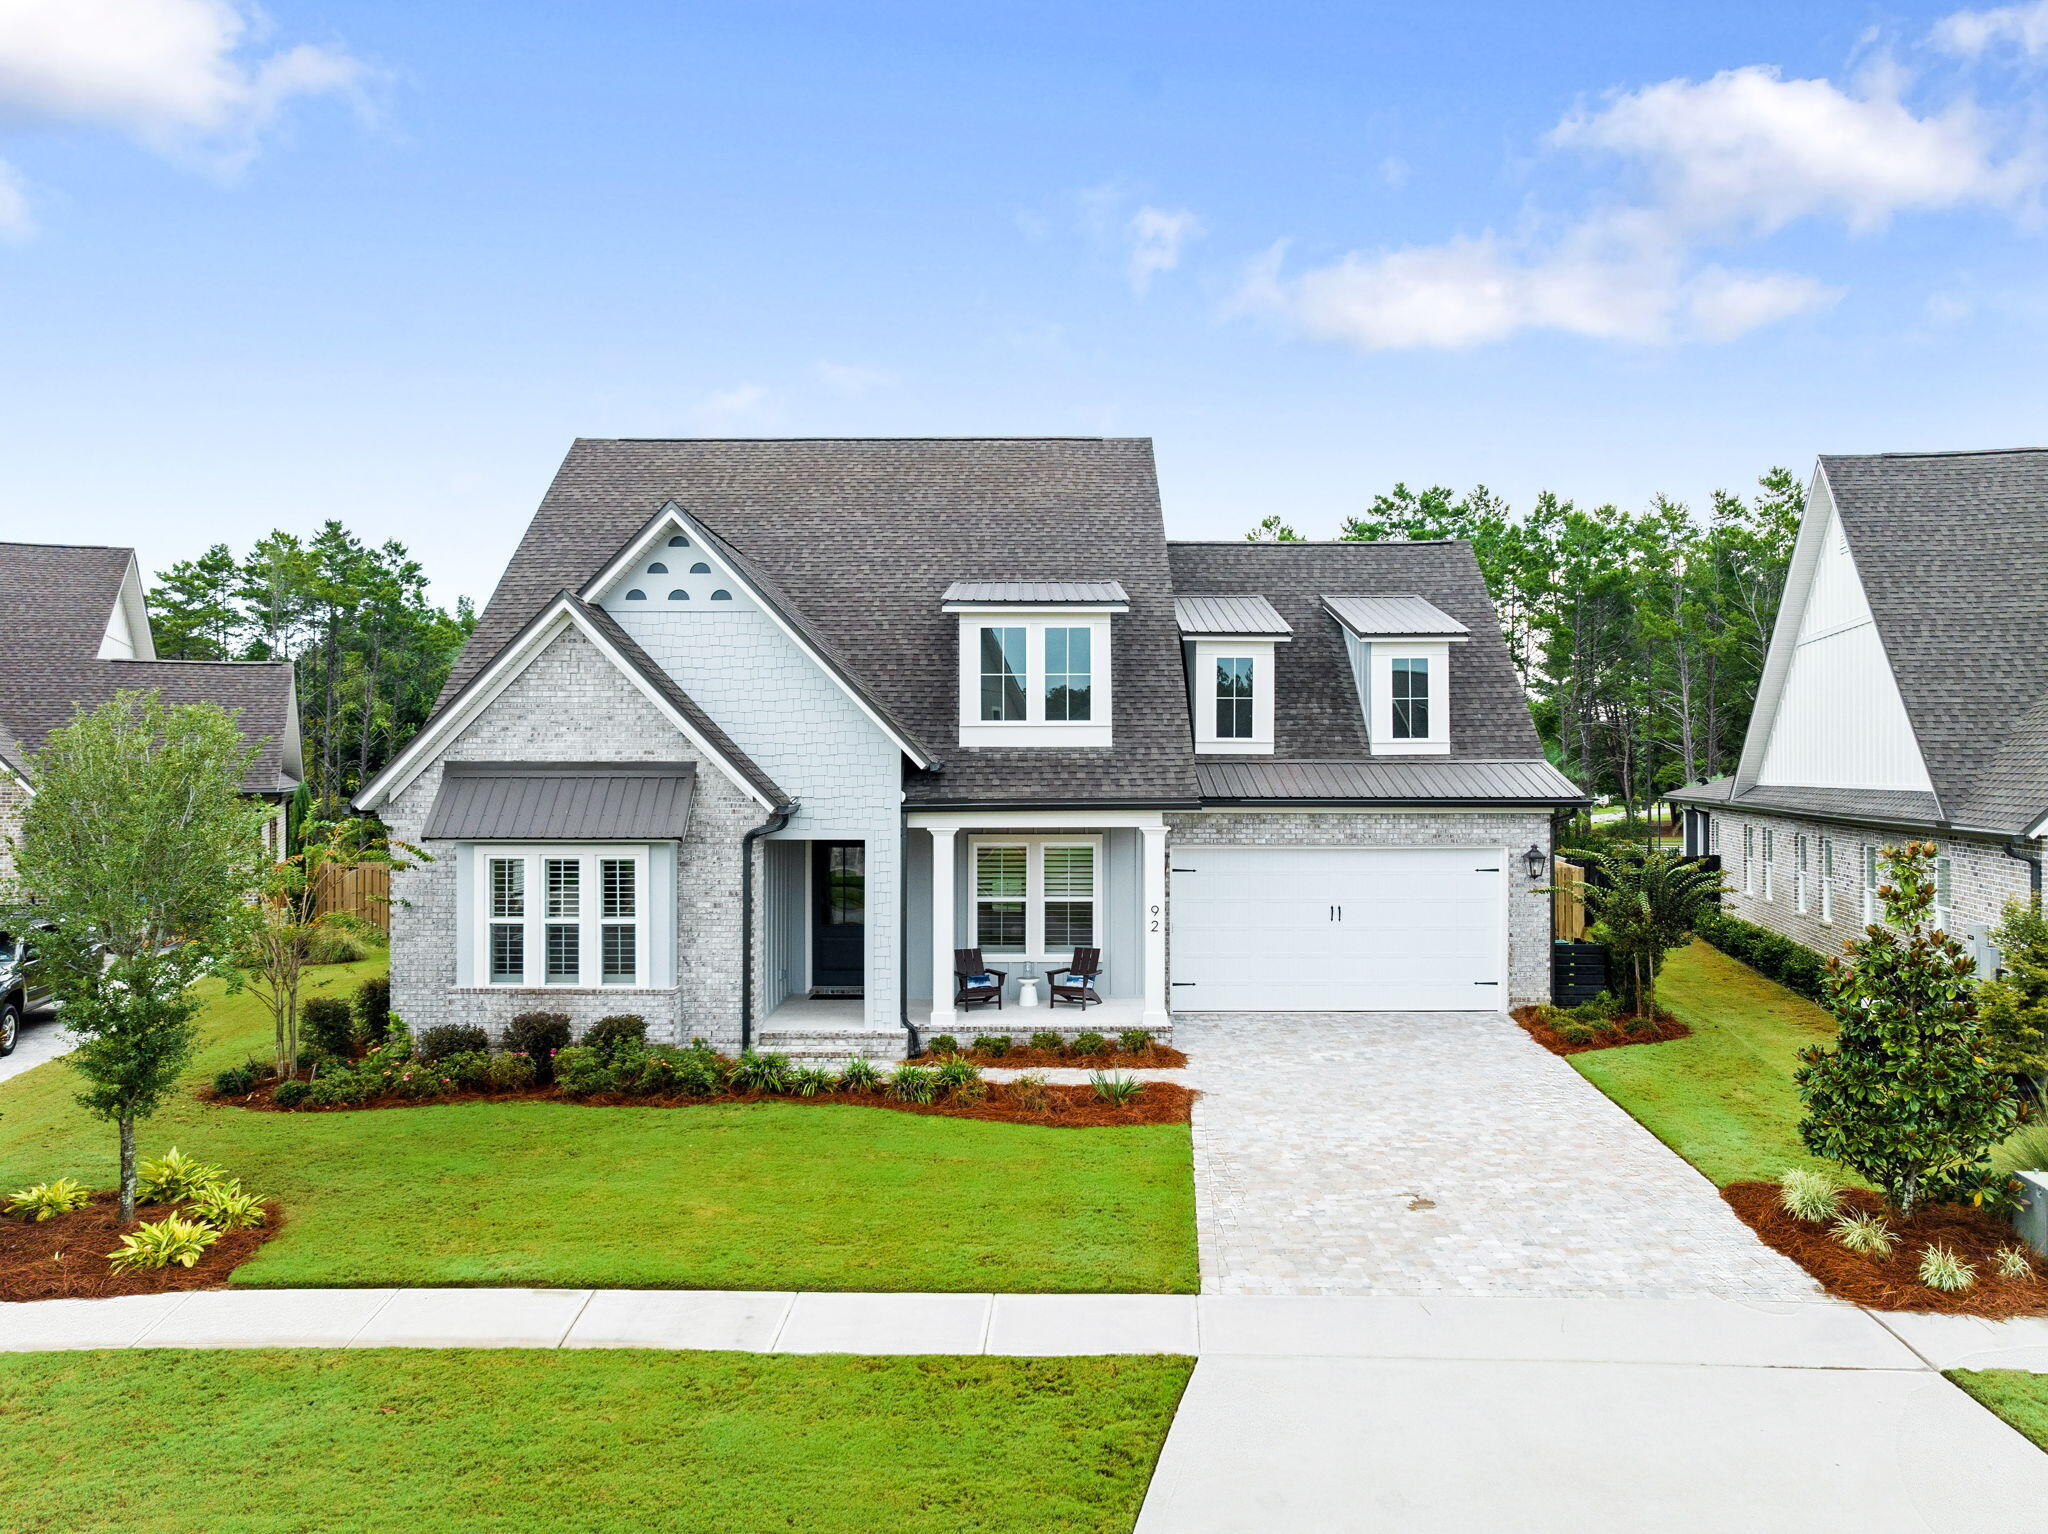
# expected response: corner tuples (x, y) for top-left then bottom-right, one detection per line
(0, 1192), (283, 1301)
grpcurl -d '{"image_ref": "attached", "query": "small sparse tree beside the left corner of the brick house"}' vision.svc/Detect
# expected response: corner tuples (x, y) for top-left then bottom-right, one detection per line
(233, 819), (424, 1081)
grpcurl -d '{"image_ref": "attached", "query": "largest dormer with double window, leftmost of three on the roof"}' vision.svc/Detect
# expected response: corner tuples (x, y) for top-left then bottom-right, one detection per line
(944, 582), (1128, 745)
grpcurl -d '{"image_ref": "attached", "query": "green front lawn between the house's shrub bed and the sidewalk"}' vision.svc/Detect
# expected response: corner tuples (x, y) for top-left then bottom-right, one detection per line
(0, 965), (1196, 1292)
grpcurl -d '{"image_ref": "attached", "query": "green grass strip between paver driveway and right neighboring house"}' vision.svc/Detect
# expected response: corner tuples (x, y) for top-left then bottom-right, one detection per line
(1569, 942), (1839, 1186)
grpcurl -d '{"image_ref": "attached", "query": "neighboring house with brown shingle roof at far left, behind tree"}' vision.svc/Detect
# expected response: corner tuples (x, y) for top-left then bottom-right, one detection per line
(0, 543), (301, 891)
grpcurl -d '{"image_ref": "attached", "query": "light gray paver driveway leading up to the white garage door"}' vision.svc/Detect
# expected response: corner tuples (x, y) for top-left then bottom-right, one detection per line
(1174, 1012), (1821, 1301)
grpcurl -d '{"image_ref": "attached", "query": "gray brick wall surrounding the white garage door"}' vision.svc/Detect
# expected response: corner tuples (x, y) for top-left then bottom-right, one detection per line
(1167, 809), (1550, 1006)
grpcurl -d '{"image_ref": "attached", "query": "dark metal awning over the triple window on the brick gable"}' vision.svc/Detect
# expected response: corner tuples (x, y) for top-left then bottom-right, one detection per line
(422, 762), (696, 842)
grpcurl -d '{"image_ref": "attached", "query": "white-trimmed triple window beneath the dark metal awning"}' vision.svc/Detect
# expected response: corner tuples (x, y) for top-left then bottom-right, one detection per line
(477, 846), (649, 989)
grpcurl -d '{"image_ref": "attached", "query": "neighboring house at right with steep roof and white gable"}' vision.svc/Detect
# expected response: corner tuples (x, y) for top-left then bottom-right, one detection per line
(1671, 449), (2048, 963)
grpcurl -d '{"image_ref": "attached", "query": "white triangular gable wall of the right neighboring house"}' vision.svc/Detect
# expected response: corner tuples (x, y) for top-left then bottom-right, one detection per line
(1737, 471), (1925, 793)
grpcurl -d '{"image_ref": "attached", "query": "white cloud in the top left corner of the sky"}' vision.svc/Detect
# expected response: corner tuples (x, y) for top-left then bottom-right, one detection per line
(0, 0), (369, 227)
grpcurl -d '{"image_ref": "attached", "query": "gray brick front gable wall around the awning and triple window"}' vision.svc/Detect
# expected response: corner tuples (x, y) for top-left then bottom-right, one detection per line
(385, 629), (766, 1049)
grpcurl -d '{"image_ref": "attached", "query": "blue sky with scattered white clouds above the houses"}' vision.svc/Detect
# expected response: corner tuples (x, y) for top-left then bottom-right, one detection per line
(0, 0), (2048, 598)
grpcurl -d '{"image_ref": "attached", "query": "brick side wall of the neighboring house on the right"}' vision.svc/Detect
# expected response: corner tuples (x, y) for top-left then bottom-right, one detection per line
(1706, 809), (2030, 956)
